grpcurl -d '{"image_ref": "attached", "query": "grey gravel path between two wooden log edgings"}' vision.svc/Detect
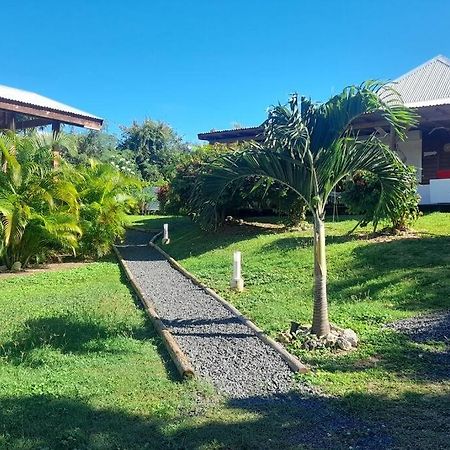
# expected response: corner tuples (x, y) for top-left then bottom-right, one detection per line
(118, 230), (311, 398)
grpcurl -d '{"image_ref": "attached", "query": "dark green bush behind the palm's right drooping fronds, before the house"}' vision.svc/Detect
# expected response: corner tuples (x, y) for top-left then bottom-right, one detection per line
(340, 166), (420, 234)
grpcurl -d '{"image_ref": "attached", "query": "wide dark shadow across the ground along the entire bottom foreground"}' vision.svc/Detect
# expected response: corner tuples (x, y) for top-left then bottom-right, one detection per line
(0, 392), (450, 450)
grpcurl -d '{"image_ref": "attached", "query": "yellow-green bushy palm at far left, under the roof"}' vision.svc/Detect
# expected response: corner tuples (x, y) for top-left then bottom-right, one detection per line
(0, 133), (81, 268)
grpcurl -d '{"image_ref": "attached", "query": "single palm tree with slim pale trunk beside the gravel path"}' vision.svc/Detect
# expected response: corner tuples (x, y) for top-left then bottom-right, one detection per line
(192, 82), (415, 336)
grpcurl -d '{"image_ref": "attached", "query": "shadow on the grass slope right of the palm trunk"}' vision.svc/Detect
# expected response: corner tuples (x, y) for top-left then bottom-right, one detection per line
(328, 235), (450, 311)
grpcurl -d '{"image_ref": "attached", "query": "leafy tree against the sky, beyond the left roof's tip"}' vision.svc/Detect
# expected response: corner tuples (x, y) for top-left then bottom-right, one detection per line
(118, 119), (189, 181)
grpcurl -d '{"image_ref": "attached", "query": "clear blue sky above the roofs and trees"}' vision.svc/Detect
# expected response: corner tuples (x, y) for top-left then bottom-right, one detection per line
(0, 0), (450, 141)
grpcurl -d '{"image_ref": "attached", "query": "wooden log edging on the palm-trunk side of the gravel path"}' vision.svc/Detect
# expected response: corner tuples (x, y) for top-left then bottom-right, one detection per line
(149, 232), (310, 373)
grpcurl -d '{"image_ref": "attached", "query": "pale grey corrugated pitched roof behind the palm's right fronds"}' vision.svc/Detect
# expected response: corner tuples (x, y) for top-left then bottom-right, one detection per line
(392, 55), (450, 107)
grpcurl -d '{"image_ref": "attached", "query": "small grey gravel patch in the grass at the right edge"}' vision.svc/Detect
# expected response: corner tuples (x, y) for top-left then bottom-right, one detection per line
(386, 311), (450, 342)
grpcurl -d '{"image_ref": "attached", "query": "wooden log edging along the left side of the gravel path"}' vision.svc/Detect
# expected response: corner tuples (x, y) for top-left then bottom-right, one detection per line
(113, 245), (195, 379)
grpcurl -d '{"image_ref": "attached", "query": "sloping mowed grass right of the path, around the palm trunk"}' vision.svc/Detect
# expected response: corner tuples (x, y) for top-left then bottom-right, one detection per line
(133, 213), (450, 448)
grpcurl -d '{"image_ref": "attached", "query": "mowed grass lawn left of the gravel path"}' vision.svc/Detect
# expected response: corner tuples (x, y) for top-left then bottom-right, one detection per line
(0, 260), (326, 450)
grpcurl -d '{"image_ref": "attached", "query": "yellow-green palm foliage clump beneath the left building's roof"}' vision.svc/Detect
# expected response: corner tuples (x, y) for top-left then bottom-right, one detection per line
(0, 133), (143, 268)
